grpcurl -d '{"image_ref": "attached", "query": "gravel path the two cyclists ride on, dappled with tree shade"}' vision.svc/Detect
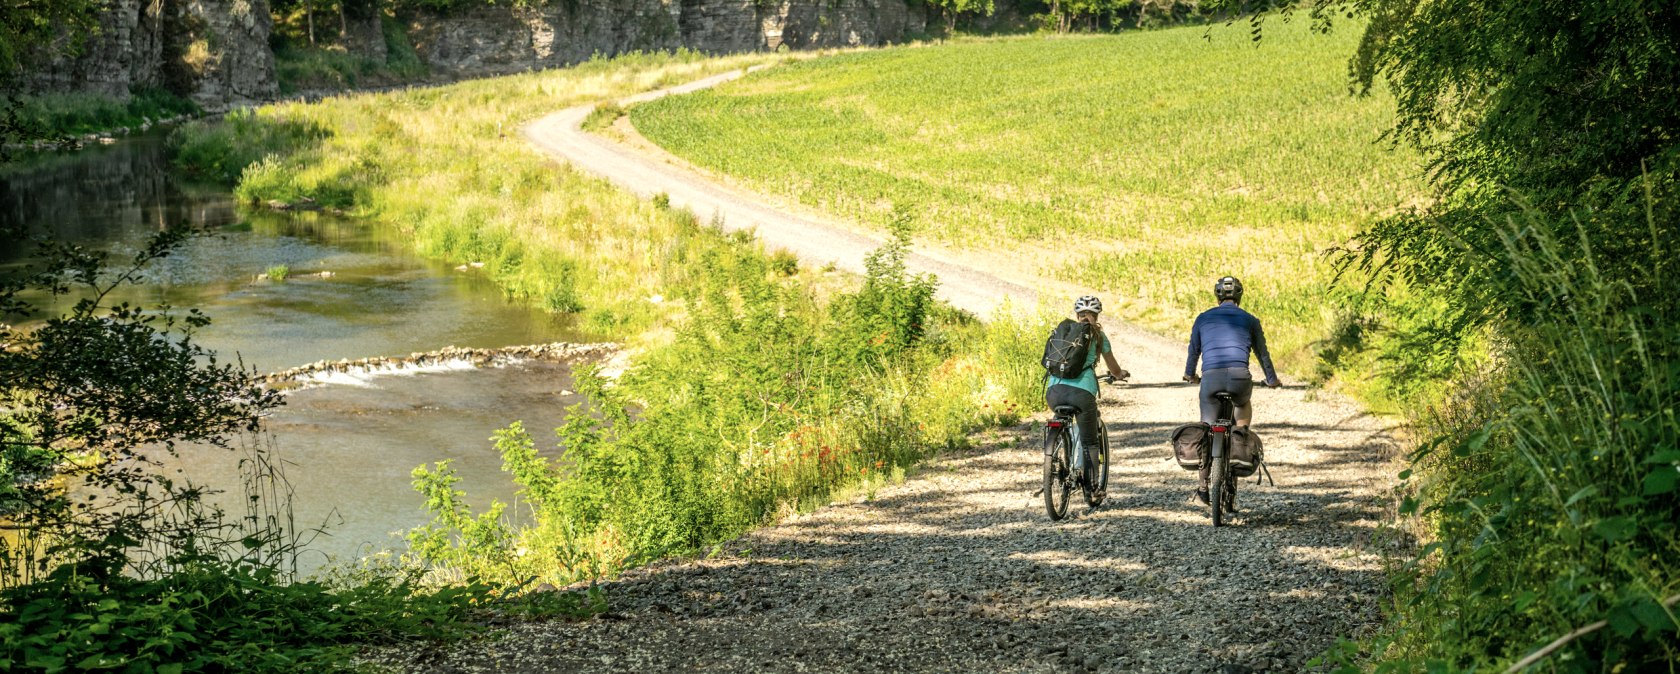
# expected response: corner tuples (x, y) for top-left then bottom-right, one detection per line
(426, 71), (1394, 672)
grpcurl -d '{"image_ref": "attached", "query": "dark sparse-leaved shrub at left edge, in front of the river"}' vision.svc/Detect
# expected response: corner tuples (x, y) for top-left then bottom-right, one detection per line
(0, 227), (281, 587)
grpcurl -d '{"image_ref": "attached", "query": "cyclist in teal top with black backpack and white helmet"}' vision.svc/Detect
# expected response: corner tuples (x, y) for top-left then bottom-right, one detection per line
(1043, 294), (1132, 455)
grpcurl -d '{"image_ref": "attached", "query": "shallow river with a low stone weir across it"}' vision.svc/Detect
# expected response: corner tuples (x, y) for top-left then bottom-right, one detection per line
(0, 134), (598, 568)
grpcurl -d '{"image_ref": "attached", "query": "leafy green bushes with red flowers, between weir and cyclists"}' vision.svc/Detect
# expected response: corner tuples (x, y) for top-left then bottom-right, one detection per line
(410, 234), (1045, 583)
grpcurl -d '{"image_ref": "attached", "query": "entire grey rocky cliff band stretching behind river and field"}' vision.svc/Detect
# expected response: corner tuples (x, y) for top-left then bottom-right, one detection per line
(25, 0), (927, 109)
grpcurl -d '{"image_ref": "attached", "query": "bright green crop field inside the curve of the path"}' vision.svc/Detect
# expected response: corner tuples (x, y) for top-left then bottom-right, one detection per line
(630, 22), (1423, 371)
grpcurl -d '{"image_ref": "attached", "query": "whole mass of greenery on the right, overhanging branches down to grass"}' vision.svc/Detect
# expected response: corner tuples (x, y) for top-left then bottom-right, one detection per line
(1223, 0), (1680, 672)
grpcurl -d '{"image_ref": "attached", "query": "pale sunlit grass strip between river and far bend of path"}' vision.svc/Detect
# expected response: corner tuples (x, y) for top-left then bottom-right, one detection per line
(176, 52), (778, 334)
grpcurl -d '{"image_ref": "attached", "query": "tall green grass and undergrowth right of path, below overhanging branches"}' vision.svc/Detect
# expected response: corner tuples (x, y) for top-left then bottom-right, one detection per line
(1369, 208), (1680, 672)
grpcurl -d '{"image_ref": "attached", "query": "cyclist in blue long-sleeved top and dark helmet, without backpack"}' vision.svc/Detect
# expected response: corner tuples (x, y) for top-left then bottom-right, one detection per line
(1184, 276), (1280, 503)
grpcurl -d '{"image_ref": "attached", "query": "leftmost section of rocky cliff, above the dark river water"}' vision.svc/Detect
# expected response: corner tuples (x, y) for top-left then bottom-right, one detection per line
(27, 0), (279, 109)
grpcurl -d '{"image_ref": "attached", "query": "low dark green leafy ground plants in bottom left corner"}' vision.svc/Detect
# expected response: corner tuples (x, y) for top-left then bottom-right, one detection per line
(0, 558), (496, 672)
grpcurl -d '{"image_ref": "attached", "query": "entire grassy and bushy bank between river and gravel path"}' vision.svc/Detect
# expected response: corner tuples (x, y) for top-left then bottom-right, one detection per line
(170, 54), (1038, 585)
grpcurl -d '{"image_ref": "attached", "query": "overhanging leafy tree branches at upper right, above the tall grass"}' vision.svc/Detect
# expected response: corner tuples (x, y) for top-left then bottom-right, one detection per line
(1352, 0), (1680, 351)
